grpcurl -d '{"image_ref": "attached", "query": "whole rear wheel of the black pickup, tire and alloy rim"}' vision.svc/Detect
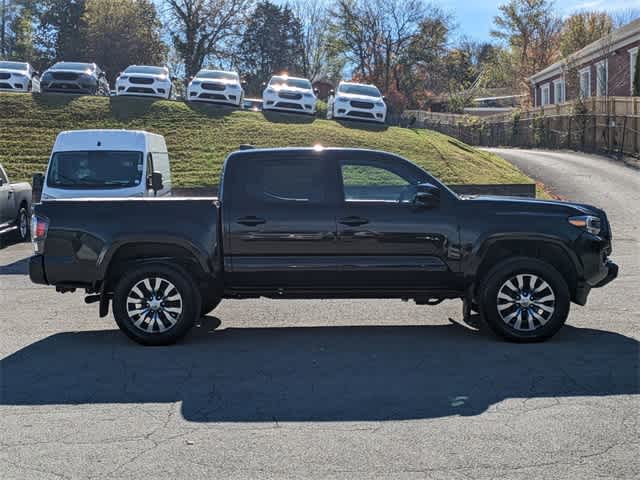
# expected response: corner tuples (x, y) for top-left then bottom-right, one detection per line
(113, 263), (202, 345)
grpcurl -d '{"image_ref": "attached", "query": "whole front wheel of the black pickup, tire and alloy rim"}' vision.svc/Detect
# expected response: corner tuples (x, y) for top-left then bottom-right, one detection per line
(478, 257), (571, 343)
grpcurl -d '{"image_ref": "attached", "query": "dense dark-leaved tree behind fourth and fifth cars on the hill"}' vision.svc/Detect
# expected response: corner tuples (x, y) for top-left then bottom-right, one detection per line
(236, 1), (305, 93)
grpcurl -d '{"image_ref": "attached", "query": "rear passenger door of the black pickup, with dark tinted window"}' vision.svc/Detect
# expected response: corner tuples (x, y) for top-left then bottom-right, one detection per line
(222, 150), (337, 289)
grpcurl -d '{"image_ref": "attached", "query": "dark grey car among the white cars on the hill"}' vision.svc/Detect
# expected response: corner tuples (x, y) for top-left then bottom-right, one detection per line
(40, 62), (109, 96)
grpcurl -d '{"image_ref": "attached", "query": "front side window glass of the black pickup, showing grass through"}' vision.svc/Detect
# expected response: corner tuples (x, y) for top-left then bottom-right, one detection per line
(341, 162), (418, 203)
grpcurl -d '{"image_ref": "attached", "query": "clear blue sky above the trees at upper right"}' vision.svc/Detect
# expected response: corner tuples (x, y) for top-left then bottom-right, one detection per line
(444, 0), (640, 40)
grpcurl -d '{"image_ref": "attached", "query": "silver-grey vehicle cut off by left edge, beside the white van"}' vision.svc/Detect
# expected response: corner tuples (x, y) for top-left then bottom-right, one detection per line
(0, 165), (31, 241)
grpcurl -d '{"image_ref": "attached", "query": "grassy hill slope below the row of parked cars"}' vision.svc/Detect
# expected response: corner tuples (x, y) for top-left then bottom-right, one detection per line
(0, 94), (531, 187)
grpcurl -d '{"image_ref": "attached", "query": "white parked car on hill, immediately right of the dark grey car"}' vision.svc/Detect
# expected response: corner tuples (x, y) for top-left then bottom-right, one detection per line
(116, 65), (173, 99)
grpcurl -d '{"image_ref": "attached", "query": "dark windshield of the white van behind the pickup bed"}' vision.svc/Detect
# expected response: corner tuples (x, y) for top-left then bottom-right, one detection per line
(47, 151), (143, 189)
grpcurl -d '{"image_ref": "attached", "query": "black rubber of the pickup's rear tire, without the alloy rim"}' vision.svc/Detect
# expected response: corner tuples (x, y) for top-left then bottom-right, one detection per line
(113, 263), (201, 345)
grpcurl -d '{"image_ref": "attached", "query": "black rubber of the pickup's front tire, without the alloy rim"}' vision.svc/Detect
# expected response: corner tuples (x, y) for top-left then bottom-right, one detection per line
(478, 257), (571, 342)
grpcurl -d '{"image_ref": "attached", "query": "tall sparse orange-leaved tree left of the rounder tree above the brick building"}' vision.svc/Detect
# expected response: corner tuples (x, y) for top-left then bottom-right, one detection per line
(491, 0), (562, 95)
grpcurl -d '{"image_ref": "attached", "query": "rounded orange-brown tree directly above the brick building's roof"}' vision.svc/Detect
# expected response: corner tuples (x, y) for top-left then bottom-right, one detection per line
(560, 12), (613, 57)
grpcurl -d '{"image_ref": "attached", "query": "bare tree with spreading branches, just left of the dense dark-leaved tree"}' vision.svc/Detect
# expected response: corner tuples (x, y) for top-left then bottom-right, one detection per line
(166, 0), (253, 78)
